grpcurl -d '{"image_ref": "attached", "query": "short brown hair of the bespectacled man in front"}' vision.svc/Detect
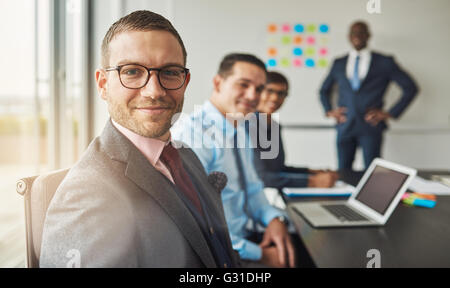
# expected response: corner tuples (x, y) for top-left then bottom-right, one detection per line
(101, 10), (187, 67)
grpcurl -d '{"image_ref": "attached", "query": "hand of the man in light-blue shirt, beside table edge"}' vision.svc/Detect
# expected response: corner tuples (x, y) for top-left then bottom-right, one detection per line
(259, 218), (295, 268)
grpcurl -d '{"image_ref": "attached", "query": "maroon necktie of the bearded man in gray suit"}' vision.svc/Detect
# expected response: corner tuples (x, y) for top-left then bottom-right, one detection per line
(160, 143), (203, 215)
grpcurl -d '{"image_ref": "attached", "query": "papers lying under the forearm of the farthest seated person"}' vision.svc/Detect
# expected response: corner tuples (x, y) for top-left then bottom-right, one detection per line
(283, 181), (356, 197)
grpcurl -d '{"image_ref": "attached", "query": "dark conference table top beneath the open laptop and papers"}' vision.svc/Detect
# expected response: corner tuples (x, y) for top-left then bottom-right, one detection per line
(283, 171), (450, 268)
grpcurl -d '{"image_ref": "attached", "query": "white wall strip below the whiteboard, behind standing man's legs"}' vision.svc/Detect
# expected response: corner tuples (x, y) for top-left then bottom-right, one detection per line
(283, 127), (450, 170)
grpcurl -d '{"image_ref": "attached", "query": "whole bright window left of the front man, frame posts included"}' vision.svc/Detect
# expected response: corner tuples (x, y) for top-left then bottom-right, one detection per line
(0, 0), (89, 267)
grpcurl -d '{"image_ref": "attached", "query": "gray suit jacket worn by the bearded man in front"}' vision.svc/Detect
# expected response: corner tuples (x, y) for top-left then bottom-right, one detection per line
(40, 121), (238, 267)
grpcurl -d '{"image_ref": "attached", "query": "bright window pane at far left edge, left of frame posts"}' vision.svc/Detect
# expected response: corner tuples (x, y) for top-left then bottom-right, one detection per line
(0, 0), (49, 267)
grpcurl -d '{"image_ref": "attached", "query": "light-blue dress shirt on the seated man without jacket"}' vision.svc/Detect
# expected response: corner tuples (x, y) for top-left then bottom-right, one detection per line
(171, 101), (285, 261)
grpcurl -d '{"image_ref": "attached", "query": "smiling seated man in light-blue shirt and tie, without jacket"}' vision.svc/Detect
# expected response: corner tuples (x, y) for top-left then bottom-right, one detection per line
(172, 54), (295, 267)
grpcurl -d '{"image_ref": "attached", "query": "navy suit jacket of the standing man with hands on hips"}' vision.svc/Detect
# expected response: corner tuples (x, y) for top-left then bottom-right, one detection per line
(320, 52), (418, 135)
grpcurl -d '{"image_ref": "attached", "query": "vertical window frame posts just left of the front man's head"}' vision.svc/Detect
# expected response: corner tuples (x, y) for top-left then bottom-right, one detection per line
(48, 0), (93, 170)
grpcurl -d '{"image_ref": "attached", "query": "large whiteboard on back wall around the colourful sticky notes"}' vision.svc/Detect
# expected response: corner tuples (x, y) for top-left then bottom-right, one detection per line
(126, 0), (450, 127)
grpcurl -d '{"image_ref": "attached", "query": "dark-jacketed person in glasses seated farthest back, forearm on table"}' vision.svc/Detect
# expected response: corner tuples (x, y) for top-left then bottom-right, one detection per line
(254, 72), (337, 189)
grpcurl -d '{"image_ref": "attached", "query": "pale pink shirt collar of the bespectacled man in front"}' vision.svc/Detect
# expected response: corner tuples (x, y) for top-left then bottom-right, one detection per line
(111, 119), (171, 166)
